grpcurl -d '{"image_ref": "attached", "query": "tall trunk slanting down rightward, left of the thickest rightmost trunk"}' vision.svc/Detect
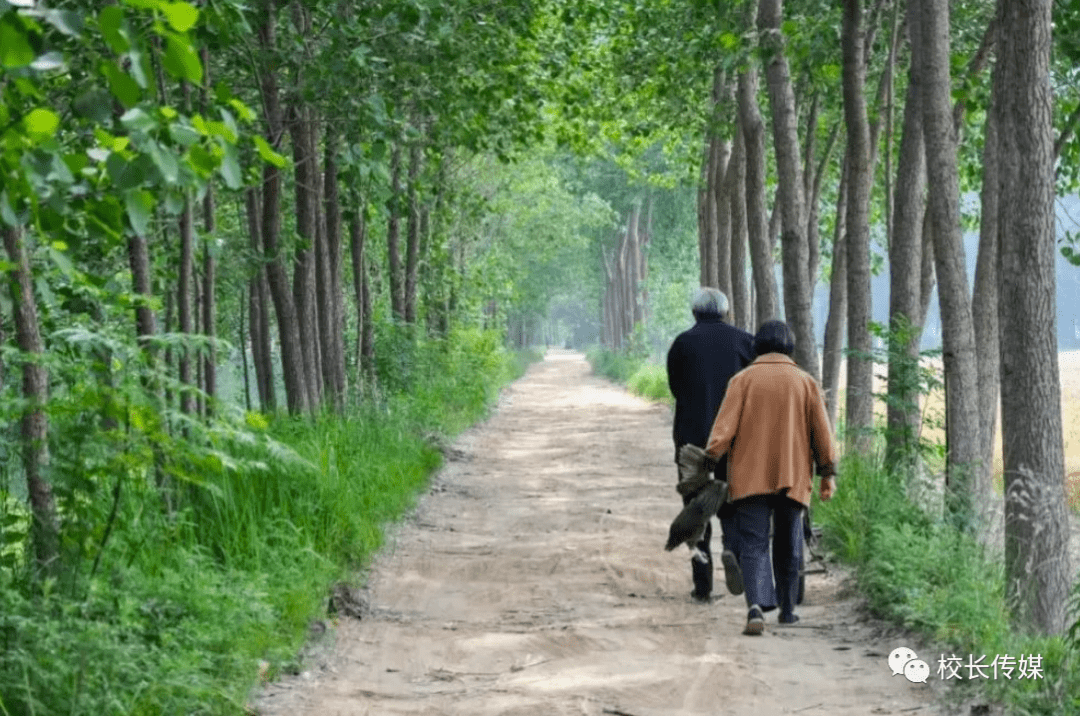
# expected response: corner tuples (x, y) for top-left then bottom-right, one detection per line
(912, 0), (980, 527)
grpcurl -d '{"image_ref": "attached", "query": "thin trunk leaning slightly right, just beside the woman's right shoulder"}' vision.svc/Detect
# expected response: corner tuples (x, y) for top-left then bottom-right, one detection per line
(821, 152), (848, 428)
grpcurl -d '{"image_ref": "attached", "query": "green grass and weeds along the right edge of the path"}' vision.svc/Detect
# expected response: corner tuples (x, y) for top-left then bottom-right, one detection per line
(813, 456), (1080, 716)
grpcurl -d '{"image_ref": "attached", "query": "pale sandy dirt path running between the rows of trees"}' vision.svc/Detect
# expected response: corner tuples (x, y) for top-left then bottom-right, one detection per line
(255, 351), (936, 716)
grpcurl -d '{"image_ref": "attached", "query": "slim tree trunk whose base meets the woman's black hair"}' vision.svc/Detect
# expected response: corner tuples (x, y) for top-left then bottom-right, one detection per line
(739, 67), (780, 326)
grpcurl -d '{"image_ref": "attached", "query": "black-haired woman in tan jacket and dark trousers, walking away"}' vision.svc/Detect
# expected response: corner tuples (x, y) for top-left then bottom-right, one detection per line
(705, 321), (836, 635)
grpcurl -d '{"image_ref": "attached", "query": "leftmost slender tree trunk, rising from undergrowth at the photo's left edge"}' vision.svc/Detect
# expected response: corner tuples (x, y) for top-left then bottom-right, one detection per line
(0, 226), (60, 576)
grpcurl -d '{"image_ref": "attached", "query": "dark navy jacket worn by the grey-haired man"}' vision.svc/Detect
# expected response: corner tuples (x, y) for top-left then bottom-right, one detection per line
(667, 316), (754, 473)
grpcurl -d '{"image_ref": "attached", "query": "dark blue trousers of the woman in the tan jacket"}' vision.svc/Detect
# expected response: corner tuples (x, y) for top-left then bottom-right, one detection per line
(731, 495), (804, 618)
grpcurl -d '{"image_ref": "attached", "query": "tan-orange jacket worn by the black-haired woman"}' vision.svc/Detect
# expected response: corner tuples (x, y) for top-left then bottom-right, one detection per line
(705, 353), (836, 504)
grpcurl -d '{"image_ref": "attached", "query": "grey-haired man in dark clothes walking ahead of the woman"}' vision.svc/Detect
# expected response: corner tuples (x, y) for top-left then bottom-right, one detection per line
(667, 287), (754, 602)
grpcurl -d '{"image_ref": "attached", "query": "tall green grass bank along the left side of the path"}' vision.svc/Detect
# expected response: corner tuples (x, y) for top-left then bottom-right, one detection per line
(0, 330), (525, 716)
